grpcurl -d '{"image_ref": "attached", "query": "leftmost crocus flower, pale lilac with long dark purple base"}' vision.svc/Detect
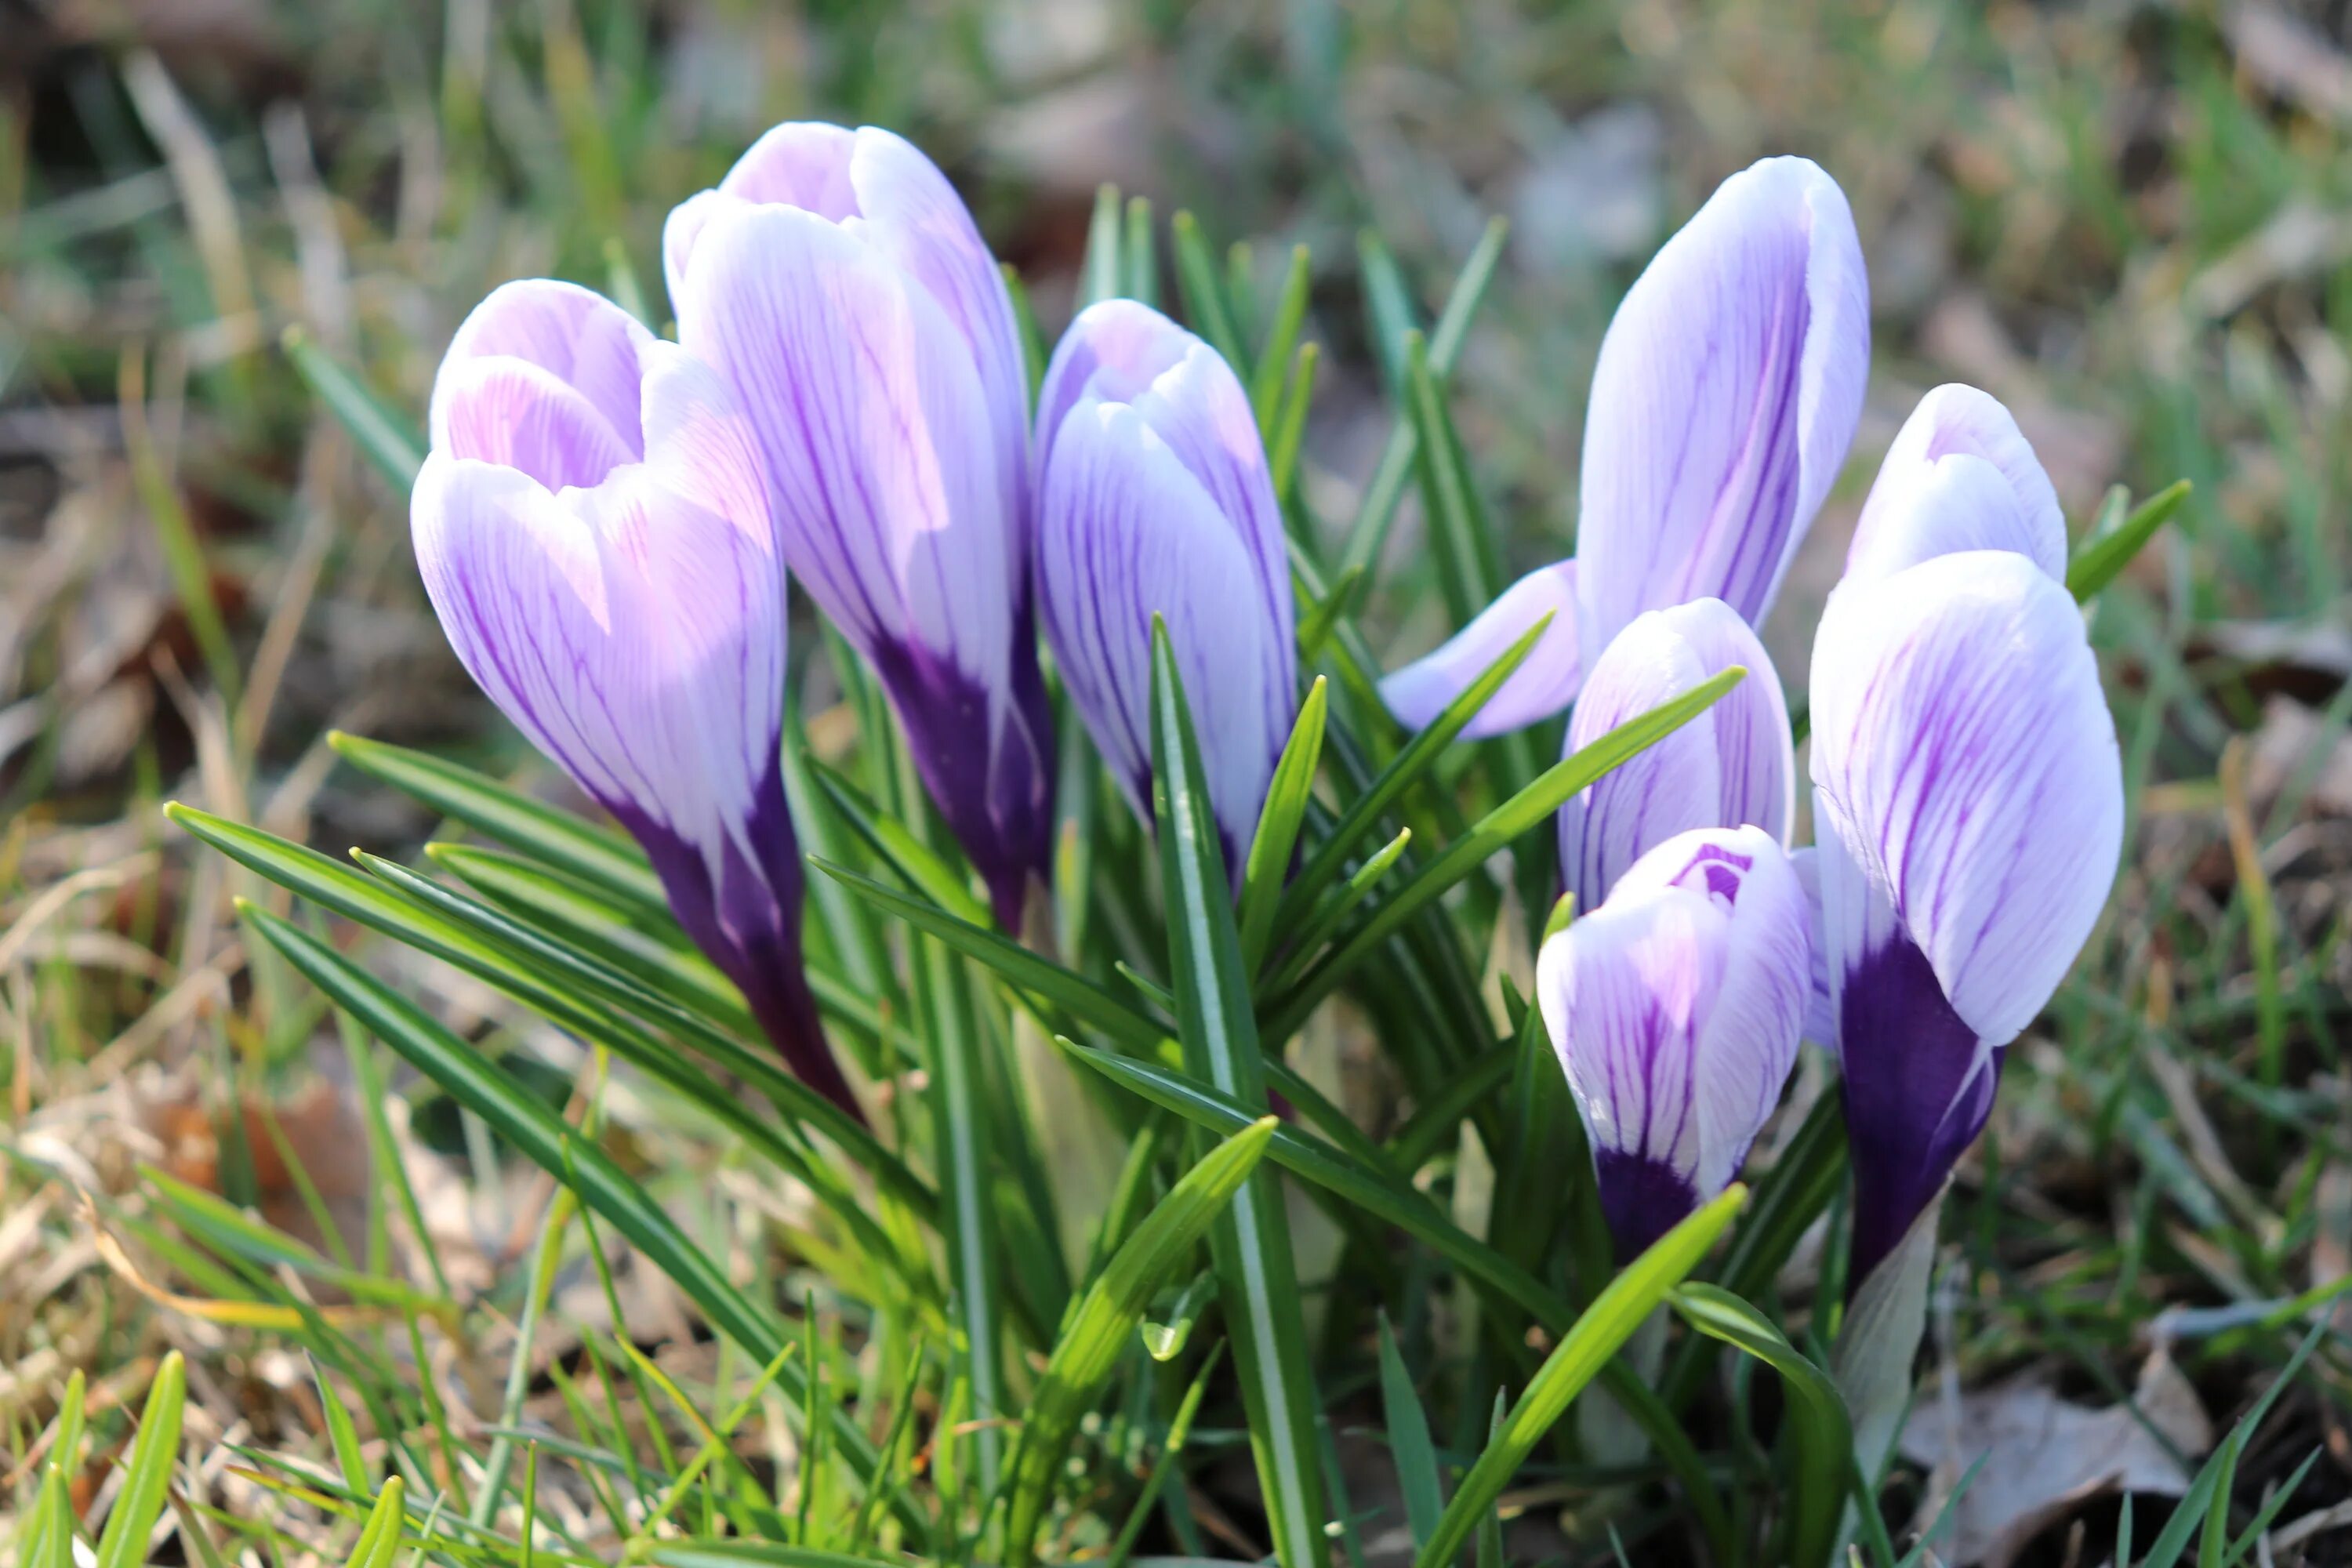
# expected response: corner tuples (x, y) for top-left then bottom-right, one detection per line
(409, 280), (856, 1114)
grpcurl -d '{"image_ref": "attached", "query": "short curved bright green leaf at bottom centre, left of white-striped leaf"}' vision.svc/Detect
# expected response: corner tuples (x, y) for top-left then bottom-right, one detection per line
(1004, 1116), (1279, 1568)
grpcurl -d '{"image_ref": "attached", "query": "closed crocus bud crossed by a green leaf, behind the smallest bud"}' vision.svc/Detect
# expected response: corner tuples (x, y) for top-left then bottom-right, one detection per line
(1559, 600), (1797, 909)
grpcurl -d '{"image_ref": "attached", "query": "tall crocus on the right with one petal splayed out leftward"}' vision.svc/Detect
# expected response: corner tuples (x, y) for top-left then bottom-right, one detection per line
(1381, 158), (1870, 739)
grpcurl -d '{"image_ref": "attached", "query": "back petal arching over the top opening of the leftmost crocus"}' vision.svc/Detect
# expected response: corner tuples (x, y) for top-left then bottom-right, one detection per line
(428, 278), (654, 459)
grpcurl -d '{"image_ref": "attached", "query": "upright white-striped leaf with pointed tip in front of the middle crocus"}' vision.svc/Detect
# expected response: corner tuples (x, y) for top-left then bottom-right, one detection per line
(1152, 616), (1324, 1568)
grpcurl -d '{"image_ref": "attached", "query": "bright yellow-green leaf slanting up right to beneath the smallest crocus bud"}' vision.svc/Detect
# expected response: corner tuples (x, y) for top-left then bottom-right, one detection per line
(1414, 1182), (1748, 1568)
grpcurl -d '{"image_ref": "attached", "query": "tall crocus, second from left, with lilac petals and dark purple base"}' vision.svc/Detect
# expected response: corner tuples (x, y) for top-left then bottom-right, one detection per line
(663, 125), (1054, 926)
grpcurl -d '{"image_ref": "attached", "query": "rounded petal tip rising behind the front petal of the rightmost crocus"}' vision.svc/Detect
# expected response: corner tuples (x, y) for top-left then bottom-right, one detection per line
(1846, 383), (2067, 583)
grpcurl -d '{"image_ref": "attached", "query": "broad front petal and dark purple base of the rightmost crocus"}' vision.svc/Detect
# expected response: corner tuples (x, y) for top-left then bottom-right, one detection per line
(1811, 550), (2124, 1281)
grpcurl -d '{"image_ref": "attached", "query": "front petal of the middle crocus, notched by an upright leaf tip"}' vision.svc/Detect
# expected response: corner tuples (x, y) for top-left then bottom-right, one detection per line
(1037, 397), (1291, 872)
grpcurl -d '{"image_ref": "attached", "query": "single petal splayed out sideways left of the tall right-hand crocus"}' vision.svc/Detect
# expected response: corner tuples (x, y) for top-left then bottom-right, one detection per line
(1381, 562), (1583, 741)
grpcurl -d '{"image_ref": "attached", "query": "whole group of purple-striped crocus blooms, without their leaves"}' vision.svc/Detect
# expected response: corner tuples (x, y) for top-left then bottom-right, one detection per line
(412, 125), (2122, 1420)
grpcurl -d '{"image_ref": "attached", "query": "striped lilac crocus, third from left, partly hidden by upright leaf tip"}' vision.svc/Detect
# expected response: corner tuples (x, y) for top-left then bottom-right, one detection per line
(1037, 299), (1298, 874)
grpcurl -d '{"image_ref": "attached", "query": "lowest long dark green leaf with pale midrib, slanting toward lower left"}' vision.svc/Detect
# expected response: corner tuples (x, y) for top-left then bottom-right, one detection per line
(240, 905), (924, 1537)
